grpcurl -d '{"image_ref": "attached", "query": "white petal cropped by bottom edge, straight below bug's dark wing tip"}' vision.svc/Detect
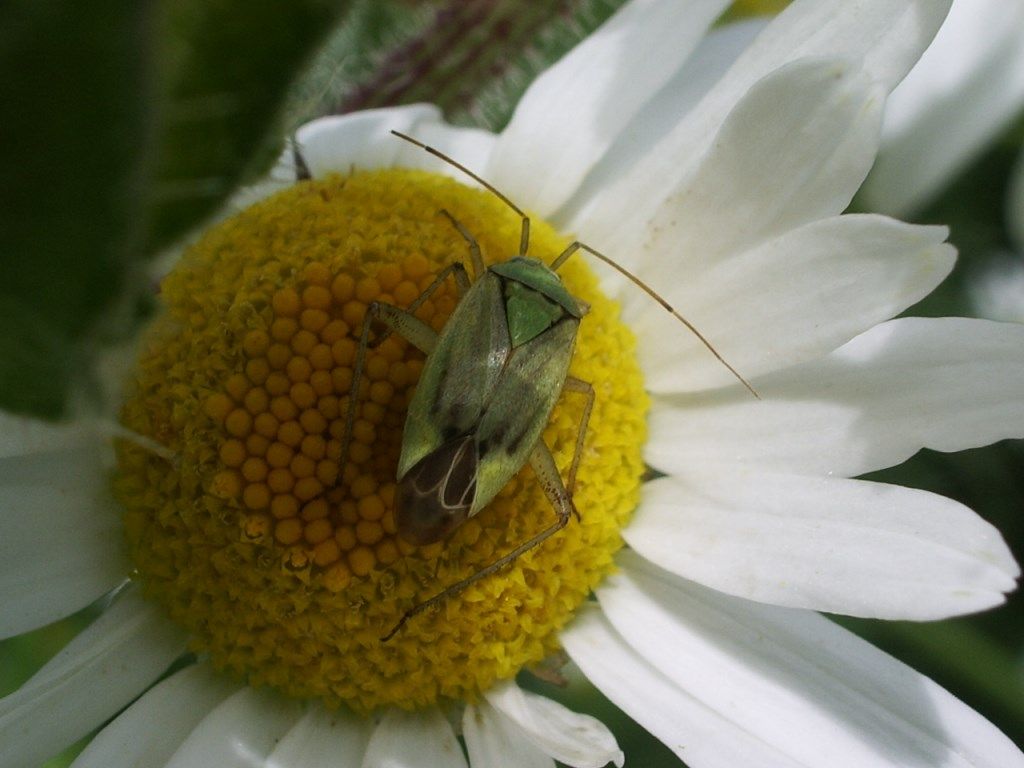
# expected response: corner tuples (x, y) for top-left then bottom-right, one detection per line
(362, 708), (466, 768)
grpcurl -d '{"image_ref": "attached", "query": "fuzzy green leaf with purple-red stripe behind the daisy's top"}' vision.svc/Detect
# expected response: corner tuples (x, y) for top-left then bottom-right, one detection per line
(289, 0), (625, 130)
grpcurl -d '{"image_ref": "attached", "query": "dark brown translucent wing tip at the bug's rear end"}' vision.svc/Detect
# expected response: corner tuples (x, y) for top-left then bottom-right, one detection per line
(394, 435), (477, 546)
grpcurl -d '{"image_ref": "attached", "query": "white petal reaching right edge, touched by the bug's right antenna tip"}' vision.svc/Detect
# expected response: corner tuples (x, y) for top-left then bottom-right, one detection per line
(645, 317), (1024, 477)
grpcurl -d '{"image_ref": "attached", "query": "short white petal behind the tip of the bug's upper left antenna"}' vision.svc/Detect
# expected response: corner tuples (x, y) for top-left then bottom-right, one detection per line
(296, 104), (494, 182)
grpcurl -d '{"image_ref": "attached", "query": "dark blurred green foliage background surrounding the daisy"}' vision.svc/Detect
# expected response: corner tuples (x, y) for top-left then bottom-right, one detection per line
(0, 0), (1024, 768)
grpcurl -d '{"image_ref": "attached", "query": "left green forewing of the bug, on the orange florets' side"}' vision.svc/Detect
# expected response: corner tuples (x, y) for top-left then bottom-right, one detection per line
(398, 272), (511, 479)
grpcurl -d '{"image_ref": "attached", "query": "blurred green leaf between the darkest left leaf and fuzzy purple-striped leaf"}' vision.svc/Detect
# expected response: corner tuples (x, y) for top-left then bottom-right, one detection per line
(150, 0), (348, 248)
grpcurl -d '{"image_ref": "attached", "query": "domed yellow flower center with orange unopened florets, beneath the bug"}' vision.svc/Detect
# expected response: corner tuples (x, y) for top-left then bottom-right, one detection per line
(115, 165), (646, 712)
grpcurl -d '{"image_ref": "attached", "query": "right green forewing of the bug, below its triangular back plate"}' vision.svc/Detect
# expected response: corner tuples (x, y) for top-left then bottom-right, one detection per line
(470, 315), (580, 516)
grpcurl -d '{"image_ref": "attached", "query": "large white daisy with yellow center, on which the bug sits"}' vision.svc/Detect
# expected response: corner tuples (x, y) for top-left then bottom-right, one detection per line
(0, 0), (1024, 768)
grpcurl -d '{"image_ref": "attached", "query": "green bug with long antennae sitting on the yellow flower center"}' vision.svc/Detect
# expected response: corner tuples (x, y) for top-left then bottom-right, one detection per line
(341, 131), (757, 641)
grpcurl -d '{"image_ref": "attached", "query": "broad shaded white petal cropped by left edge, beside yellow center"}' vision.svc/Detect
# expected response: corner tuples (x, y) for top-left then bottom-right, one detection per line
(0, 442), (129, 638)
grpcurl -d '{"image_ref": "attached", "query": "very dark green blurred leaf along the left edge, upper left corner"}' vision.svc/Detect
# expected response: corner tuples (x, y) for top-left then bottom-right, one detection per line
(0, 0), (152, 418)
